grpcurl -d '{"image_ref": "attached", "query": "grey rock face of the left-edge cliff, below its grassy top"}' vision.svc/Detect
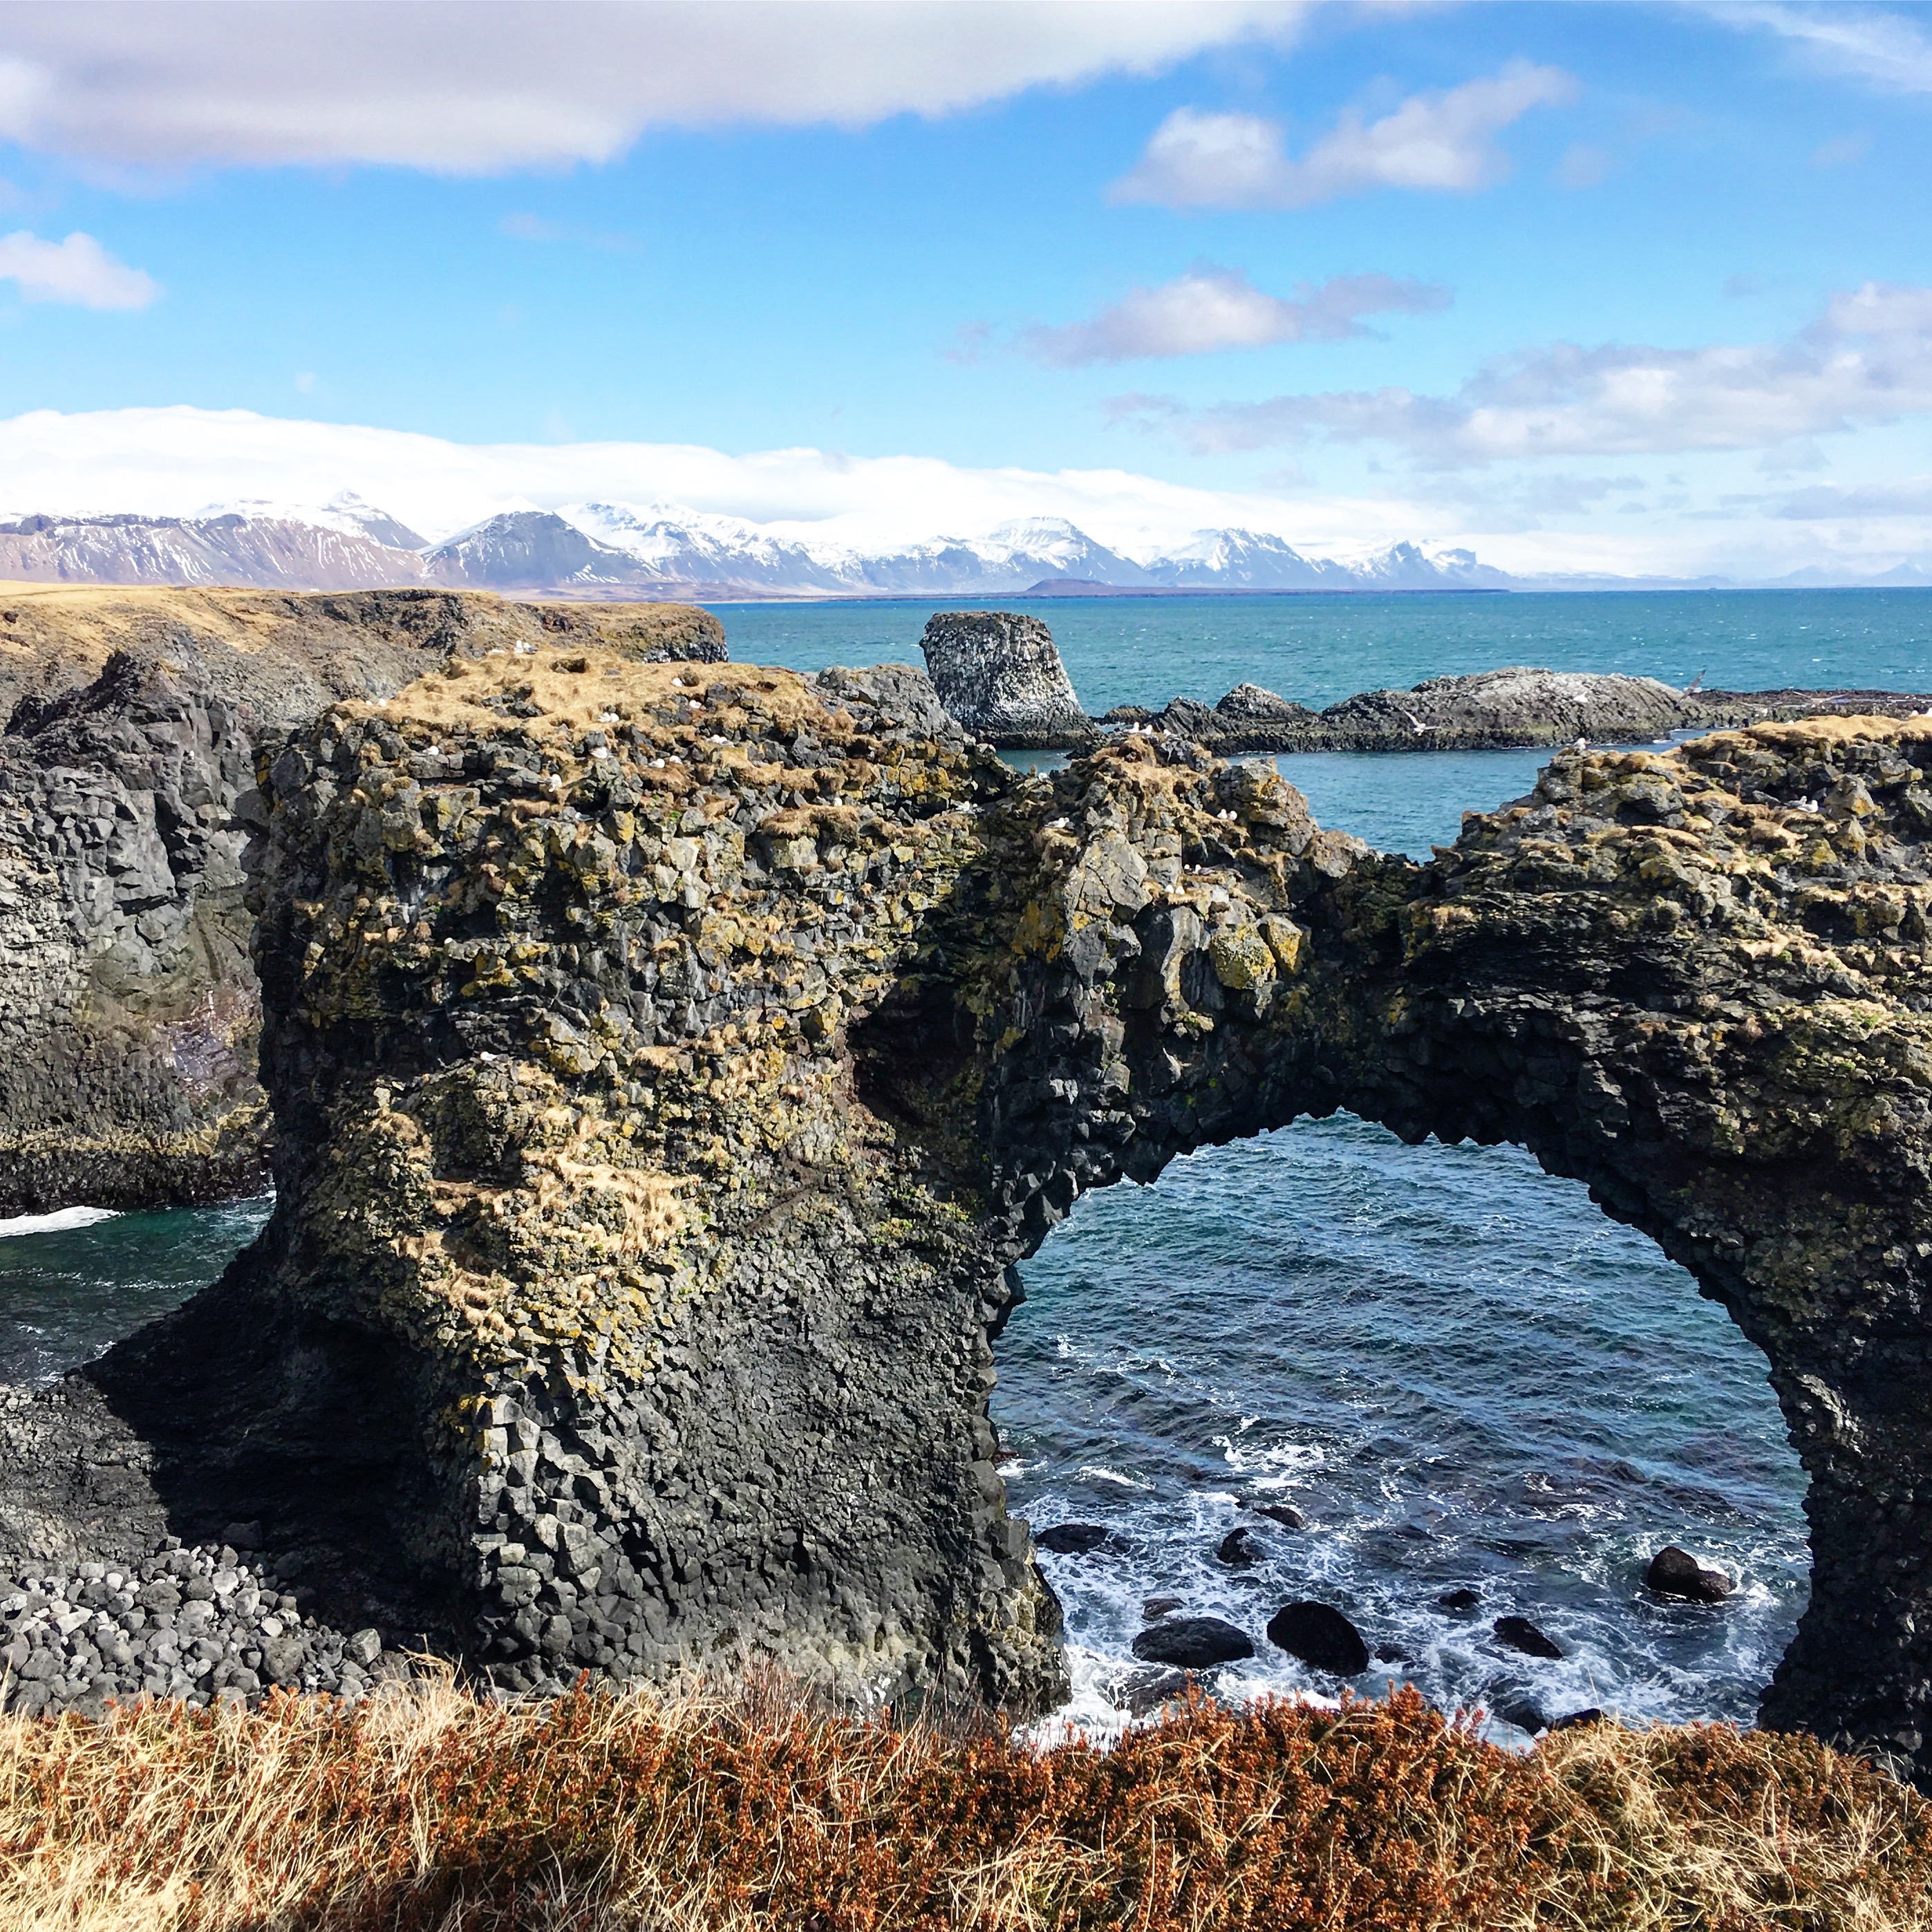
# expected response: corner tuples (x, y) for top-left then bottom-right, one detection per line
(0, 655), (267, 1213)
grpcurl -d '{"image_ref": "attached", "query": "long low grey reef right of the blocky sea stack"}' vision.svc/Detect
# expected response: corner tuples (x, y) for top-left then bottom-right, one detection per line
(1101, 668), (1932, 758)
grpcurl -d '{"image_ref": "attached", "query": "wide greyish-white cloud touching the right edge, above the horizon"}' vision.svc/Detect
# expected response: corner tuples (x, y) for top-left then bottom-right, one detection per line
(1115, 282), (1932, 467)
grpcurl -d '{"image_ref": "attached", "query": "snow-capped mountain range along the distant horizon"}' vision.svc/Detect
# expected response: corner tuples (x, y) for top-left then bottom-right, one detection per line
(0, 493), (1932, 603)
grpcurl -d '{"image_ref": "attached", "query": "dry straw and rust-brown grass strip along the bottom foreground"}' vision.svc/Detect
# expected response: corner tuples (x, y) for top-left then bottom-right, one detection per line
(0, 1682), (1932, 1932)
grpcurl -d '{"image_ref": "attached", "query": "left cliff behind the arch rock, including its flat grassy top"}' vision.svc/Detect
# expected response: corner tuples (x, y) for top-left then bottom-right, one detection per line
(0, 588), (724, 1215)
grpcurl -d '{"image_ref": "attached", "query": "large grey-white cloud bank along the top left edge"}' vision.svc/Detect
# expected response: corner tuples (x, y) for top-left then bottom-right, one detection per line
(0, 0), (1312, 174)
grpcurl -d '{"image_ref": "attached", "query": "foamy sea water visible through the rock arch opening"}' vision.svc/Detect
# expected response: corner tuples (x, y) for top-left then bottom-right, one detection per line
(993, 1115), (1810, 1737)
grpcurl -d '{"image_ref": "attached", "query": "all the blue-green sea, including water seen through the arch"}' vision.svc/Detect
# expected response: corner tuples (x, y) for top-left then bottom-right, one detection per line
(0, 591), (1932, 1737)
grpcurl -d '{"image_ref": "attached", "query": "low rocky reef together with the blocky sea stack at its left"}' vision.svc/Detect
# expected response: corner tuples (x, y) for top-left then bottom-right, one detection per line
(923, 610), (1932, 758)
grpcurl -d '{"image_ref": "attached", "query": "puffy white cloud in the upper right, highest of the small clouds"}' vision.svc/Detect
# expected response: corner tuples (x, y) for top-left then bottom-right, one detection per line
(1113, 60), (1577, 209)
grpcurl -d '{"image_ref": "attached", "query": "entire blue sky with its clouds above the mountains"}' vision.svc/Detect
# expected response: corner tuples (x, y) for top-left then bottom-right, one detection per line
(0, 0), (1932, 572)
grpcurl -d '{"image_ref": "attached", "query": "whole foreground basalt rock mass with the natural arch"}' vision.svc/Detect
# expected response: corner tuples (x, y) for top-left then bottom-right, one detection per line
(11, 651), (1932, 1777)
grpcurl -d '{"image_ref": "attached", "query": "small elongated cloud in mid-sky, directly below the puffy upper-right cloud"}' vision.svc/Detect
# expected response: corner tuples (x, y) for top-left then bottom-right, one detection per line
(1020, 263), (1449, 369)
